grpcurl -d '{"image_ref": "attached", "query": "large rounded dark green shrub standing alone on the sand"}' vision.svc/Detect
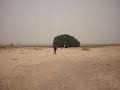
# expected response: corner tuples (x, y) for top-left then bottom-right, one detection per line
(53, 34), (80, 48)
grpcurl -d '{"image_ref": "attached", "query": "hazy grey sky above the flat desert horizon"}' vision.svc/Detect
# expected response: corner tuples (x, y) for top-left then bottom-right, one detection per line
(0, 0), (120, 44)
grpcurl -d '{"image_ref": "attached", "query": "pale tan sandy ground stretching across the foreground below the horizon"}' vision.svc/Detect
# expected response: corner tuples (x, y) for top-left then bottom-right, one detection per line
(0, 46), (120, 90)
